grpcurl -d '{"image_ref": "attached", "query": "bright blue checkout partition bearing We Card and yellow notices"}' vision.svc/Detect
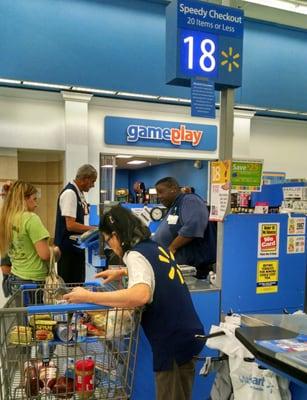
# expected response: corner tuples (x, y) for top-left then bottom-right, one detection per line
(221, 214), (306, 313)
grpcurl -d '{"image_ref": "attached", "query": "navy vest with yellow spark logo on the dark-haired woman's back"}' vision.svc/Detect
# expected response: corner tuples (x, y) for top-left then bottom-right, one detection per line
(133, 240), (204, 371)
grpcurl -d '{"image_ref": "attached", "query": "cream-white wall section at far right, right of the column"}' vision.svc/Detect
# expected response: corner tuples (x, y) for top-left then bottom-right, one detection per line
(250, 117), (307, 178)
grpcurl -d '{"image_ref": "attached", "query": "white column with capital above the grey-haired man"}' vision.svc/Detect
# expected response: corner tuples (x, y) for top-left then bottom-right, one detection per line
(61, 91), (92, 183)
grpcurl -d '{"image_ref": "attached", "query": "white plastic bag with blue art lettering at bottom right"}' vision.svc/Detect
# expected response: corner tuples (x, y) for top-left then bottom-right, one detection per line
(229, 359), (291, 400)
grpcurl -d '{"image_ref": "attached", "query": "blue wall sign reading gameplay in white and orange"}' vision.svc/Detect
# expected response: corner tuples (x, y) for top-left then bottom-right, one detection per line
(104, 117), (217, 151)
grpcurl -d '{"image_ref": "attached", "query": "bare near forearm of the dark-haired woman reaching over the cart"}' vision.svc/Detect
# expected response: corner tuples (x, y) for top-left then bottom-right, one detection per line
(63, 283), (151, 308)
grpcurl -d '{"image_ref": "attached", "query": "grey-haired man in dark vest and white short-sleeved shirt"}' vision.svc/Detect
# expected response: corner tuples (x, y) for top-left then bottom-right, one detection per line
(54, 164), (97, 283)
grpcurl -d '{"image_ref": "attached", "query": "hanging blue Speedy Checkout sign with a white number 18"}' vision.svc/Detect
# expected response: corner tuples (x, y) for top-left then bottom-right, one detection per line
(166, 0), (244, 90)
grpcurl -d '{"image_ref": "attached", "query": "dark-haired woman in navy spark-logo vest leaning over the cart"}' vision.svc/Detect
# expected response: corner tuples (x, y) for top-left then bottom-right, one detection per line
(64, 206), (204, 400)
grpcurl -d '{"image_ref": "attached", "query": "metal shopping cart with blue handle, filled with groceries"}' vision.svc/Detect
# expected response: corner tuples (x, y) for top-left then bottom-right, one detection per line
(0, 282), (142, 400)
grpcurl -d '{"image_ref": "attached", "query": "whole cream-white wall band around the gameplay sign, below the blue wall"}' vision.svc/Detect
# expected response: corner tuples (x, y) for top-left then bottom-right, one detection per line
(0, 87), (307, 198)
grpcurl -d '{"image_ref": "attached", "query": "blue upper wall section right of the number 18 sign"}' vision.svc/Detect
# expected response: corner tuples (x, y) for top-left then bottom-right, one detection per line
(241, 21), (307, 111)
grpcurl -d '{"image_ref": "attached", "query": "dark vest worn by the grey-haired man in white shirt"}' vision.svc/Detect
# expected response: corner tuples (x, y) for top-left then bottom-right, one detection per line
(54, 183), (84, 251)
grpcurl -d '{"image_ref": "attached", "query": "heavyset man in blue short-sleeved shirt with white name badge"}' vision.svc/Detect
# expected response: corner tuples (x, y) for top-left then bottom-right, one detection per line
(153, 177), (216, 279)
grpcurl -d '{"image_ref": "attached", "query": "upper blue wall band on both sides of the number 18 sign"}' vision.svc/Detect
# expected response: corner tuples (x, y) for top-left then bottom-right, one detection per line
(0, 0), (307, 111)
